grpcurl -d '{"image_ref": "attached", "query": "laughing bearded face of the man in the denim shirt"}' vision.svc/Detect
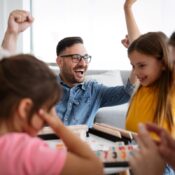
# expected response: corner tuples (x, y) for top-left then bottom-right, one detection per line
(57, 43), (88, 87)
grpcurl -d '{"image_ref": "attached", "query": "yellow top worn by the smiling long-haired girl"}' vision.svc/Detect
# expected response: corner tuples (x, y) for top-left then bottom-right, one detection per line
(126, 87), (175, 138)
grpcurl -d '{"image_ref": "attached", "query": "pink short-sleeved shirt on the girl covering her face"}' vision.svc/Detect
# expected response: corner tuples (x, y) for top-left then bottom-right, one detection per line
(0, 133), (66, 175)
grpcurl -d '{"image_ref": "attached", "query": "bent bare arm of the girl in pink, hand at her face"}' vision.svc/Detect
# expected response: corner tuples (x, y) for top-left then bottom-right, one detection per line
(39, 110), (103, 175)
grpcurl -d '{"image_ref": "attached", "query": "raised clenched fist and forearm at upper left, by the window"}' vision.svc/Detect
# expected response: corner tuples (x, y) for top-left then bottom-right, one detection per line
(1, 10), (34, 56)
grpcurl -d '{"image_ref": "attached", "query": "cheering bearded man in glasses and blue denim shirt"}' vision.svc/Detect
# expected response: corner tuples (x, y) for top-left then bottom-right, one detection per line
(56, 37), (135, 127)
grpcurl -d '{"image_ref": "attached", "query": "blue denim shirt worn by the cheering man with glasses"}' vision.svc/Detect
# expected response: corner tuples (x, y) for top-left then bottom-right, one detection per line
(56, 77), (134, 127)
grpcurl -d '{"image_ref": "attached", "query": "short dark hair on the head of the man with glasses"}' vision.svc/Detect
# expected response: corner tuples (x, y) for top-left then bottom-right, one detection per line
(56, 37), (83, 56)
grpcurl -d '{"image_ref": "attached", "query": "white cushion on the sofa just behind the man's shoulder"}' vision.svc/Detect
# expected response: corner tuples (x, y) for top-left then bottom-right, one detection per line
(85, 70), (123, 86)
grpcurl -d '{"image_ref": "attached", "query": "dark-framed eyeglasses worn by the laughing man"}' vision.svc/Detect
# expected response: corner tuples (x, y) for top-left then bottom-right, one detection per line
(60, 54), (92, 63)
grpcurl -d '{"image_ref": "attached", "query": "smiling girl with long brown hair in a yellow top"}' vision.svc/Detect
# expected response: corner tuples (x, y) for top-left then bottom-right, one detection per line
(126, 32), (175, 136)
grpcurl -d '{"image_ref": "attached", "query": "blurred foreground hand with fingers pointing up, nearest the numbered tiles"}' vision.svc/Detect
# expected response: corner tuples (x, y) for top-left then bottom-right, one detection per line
(130, 125), (165, 175)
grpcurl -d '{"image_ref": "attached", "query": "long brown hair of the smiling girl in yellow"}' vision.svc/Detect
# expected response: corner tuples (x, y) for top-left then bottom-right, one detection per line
(128, 32), (174, 130)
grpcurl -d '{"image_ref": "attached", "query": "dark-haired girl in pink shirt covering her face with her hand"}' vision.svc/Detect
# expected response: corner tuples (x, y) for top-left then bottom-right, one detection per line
(0, 54), (103, 175)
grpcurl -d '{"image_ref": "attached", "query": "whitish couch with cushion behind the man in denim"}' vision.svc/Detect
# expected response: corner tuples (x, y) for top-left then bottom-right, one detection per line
(51, 66), (129, 128)
